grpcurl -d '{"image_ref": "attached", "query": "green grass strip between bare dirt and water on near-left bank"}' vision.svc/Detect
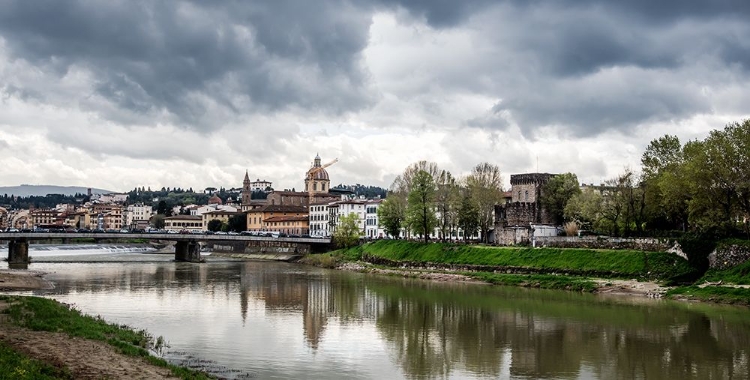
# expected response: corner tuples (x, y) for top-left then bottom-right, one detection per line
(0, 296), (213, 379)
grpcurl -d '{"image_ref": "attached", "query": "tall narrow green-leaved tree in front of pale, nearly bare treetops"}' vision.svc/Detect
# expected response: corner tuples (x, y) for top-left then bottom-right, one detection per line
(406, 170), (437, 243)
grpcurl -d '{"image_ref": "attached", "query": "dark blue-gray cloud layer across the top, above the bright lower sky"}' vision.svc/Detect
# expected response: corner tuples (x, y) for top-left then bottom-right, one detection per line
(0, 0), (750, 142)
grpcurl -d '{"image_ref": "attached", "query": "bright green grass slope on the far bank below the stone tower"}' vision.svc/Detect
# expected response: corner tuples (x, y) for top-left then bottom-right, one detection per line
(346, 240), (694, 280)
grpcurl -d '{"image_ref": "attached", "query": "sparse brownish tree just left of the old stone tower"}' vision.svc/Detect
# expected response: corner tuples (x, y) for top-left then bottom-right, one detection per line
(466, 162), (503, 243)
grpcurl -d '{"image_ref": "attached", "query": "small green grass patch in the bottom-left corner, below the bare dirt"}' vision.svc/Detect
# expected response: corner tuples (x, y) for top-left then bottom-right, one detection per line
(0, 341), (73, 380)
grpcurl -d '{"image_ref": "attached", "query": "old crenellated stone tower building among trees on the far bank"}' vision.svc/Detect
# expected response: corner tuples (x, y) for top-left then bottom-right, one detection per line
(494, 173), (557, 245)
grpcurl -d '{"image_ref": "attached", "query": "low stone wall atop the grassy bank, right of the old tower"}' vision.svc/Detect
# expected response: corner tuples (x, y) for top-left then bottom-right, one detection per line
(535, 236), (672, 252)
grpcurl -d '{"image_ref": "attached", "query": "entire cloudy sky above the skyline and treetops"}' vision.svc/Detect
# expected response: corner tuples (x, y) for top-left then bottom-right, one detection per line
(0, 0), (750, 191)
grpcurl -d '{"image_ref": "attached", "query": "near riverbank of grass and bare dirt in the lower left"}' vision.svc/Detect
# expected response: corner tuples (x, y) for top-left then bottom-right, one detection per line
(0, 270), (212, 379)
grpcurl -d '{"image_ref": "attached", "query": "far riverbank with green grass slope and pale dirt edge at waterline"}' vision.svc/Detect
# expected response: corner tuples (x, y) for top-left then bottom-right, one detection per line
(301, 240), (750, 305)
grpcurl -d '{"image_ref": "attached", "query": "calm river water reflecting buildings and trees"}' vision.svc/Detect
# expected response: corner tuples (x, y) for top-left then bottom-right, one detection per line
(0, 247), (750, 379)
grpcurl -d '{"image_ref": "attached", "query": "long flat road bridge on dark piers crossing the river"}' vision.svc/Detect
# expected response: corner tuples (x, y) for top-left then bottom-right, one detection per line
(0, 232), (331, 265)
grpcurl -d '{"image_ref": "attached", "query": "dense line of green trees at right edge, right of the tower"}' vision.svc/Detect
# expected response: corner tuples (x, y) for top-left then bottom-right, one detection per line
(563, 120), (750, 236)
